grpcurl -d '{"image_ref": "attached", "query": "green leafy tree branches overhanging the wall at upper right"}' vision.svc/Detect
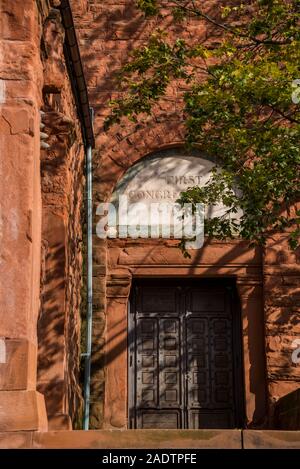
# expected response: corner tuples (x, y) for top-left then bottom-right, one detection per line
(105, 0), (300, 248)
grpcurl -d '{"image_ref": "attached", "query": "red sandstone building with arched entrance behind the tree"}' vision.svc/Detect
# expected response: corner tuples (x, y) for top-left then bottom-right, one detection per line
(0, 0), (300, 448)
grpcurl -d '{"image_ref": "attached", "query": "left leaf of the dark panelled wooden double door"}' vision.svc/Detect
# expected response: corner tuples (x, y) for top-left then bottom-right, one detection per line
(134, 286), (182, 428)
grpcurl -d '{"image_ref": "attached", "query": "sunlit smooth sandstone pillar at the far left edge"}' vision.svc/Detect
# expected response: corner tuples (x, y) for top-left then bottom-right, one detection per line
(0, 0), (47, 431)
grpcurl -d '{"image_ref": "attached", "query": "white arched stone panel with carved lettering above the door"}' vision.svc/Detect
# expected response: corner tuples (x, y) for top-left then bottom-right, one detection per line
(108, 153), (239, 238)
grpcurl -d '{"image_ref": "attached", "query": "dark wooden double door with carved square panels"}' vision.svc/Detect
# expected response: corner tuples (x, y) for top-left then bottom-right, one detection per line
(129, 280), (243, 429)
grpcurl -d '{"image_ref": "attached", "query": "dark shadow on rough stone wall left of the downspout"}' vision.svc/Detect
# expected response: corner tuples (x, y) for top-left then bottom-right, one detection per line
(37, 207), (82, 429)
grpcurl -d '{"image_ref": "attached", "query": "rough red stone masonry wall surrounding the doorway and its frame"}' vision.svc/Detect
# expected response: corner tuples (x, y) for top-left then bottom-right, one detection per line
(71, 0), (299, 428)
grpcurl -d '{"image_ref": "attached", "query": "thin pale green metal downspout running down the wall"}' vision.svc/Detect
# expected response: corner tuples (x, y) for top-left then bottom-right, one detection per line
(83, 110), (93, 430)
